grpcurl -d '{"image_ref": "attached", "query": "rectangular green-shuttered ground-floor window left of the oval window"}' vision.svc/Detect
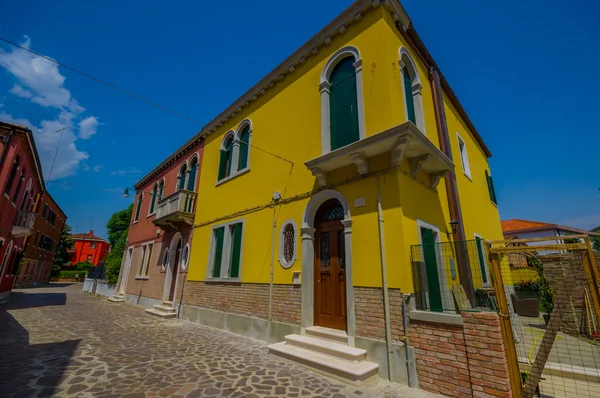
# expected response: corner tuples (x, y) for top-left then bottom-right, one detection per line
(208, 221), (244, 279)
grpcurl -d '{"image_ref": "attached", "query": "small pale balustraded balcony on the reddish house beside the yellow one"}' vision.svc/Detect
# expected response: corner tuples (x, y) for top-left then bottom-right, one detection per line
(153, 189), (197, 229)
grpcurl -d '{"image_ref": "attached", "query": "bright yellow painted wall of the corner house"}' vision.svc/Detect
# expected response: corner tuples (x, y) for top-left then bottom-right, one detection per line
(188, 7), (502, 292)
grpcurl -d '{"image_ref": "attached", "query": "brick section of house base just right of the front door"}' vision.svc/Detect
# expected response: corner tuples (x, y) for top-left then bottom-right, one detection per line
(354, 286), (404, 342)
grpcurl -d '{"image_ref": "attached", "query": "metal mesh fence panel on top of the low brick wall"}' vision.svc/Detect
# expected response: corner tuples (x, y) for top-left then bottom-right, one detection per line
(411, 239), (497, 312)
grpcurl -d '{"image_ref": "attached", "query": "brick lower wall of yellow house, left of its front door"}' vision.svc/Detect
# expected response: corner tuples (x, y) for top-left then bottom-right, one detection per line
(183, 281), (301, 325)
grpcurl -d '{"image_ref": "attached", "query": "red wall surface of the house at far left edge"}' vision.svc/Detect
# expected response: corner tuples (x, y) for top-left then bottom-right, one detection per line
(0, 124), (43, 295)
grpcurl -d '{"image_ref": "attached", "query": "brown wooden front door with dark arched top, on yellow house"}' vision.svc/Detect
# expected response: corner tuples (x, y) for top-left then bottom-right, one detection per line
(314, 200), (347, 330)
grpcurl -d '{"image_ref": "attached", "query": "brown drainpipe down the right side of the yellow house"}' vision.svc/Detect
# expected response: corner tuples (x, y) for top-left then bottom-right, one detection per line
(429, 67), (474, 303)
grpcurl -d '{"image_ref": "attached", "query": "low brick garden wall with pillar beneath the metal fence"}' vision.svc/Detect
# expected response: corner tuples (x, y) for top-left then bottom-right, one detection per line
(409, 312), (512, 398)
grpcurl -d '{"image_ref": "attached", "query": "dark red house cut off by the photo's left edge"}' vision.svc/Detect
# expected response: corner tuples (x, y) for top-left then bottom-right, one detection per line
(0, 121), (45, 298)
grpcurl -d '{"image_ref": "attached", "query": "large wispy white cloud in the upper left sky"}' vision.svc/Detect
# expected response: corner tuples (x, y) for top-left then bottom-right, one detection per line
(0, 36), (99, 180)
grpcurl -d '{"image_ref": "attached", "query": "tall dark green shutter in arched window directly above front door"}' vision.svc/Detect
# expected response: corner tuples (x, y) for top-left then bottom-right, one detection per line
(329, 58), (362, 151)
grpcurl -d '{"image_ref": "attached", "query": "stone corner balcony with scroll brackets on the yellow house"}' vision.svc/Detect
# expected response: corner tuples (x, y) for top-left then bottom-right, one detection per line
(304, 122), (454, 188)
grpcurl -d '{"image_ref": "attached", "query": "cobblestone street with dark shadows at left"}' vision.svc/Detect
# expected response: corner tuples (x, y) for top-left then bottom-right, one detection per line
(0, 284), (431, 397)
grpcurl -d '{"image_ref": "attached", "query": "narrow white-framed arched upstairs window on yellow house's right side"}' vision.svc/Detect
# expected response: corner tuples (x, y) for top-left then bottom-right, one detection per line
(399, 47), (425, 133)
